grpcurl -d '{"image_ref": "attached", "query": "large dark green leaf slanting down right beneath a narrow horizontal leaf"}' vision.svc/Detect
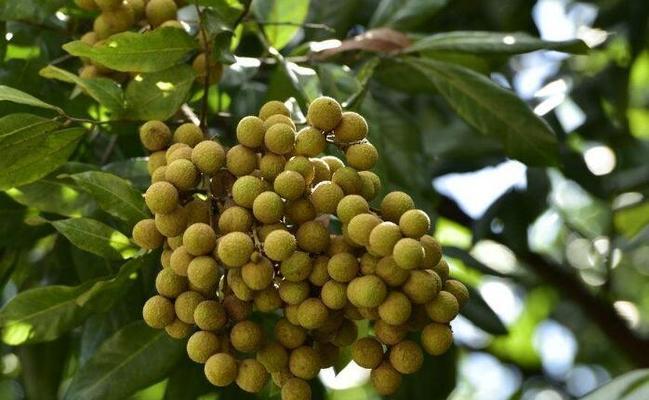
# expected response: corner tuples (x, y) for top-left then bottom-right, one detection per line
(405, 58), (559, 166)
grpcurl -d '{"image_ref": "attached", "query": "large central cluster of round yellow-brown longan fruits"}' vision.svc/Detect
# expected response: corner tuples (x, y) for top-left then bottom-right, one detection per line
(133, 97), (468, 400)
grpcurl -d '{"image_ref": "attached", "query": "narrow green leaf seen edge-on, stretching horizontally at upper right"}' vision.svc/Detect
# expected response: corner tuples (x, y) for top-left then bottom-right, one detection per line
(404, 31), (589, 55)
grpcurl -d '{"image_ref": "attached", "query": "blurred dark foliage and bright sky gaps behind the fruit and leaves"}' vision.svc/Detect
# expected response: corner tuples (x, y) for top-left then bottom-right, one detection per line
(0, 0), (649, 400)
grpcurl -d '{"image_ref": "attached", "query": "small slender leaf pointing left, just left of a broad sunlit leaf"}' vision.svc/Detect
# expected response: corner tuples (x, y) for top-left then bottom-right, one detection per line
(39, 65), (124, 115)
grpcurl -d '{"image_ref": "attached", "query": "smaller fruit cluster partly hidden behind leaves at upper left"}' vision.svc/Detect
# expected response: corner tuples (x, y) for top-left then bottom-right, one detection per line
(75, 0), (223, 84)
